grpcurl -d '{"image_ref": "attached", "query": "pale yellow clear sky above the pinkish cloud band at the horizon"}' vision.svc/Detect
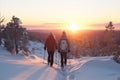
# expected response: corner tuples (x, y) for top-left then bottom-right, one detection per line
(0, 0), (120, 29)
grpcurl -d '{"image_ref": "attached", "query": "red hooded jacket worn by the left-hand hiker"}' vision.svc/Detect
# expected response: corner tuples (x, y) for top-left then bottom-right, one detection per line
(45, 33), (57, 52)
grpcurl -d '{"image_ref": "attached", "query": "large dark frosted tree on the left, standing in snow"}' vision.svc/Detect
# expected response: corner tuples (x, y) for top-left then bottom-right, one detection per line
(4, 16), (28, 54)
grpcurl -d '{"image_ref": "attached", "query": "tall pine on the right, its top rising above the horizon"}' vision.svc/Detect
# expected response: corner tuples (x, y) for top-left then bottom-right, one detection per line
(103, 21), (115, 55)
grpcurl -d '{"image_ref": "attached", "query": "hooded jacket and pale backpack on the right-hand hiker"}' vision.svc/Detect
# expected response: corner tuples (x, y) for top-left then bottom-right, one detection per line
(58, 32), (70, 53)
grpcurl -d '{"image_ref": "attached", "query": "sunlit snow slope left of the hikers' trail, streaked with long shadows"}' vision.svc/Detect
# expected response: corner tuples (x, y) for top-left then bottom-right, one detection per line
(0, 47), (65, 80)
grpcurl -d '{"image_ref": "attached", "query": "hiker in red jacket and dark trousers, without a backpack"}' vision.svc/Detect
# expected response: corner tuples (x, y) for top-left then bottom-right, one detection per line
(44, 33), (57, 67)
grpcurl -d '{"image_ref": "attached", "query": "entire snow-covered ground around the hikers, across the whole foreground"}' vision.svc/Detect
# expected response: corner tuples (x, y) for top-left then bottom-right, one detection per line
(0, 42), (120, 80)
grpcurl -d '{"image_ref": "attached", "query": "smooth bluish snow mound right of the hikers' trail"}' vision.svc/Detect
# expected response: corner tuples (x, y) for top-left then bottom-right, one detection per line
(67, 56), (120, 80)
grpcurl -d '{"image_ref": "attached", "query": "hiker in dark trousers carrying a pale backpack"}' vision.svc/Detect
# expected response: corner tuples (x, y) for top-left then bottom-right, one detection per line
(58, 32), (70, 68)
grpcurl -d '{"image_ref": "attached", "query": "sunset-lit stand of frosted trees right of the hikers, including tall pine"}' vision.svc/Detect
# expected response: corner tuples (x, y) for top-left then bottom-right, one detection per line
(74, 21), (120, 57)
